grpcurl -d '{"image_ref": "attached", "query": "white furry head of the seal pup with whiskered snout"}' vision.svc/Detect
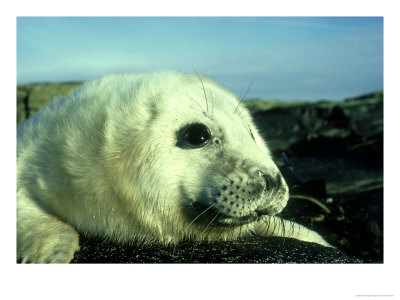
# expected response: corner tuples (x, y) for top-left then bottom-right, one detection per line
(100, 72), (288, 241)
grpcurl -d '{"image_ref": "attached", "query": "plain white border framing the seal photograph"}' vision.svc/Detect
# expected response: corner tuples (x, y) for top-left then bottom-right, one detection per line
(0, 0), (400, 299)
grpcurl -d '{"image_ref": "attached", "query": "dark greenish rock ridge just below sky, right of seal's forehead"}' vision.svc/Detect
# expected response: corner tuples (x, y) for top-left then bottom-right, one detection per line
(251, 93), (383, 151)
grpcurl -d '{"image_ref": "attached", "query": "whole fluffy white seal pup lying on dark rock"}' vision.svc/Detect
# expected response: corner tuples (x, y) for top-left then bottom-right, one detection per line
(17, 72), (328, 262)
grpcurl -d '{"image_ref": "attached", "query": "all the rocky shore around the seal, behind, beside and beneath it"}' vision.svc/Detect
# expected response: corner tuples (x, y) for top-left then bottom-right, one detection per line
(17, 82), (383, 263)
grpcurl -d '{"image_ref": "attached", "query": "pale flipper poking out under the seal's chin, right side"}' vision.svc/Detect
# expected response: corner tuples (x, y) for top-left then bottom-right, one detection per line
(254, 216), (334, 248)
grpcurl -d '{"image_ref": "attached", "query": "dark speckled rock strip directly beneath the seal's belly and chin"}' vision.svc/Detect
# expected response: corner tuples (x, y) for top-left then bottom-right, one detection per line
(72, 237), (372, 263)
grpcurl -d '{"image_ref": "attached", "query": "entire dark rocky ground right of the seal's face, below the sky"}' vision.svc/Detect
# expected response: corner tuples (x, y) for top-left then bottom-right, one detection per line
(255, 93), (383, 262)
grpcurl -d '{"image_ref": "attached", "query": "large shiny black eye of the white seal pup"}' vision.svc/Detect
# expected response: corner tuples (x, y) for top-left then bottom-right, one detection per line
(176, 123), (211, 149)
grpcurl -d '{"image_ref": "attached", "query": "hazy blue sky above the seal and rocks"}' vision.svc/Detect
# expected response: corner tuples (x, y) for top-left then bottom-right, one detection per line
(17, 17), (383, 101)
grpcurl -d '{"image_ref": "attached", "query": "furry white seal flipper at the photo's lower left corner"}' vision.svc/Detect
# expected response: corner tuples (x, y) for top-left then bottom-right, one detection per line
(17, 190), (79, 263)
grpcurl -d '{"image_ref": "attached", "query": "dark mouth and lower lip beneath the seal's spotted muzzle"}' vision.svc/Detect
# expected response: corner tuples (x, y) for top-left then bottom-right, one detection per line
(193, 201), (268, 226)
